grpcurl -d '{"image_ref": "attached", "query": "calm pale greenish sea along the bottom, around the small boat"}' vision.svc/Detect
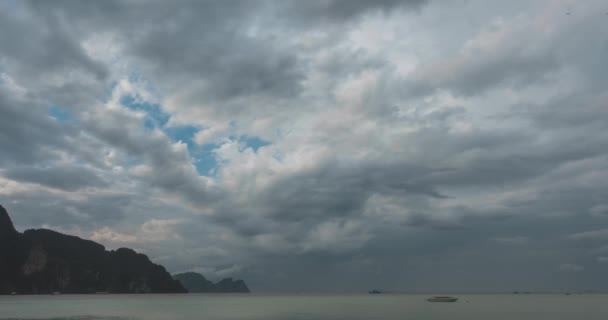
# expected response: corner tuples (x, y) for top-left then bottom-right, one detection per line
(0, 294), (608, 320)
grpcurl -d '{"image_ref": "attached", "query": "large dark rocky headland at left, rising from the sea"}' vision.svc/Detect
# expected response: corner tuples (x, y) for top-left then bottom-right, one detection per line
(0, 206), (187, 294)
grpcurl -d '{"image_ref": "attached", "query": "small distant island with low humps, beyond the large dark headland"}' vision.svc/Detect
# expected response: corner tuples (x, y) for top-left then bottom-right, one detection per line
(173, 272), (250, 293)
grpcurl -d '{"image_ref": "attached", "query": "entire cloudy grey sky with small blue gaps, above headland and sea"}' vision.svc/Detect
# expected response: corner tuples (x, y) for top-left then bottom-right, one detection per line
(0, 0), (608, 292)
